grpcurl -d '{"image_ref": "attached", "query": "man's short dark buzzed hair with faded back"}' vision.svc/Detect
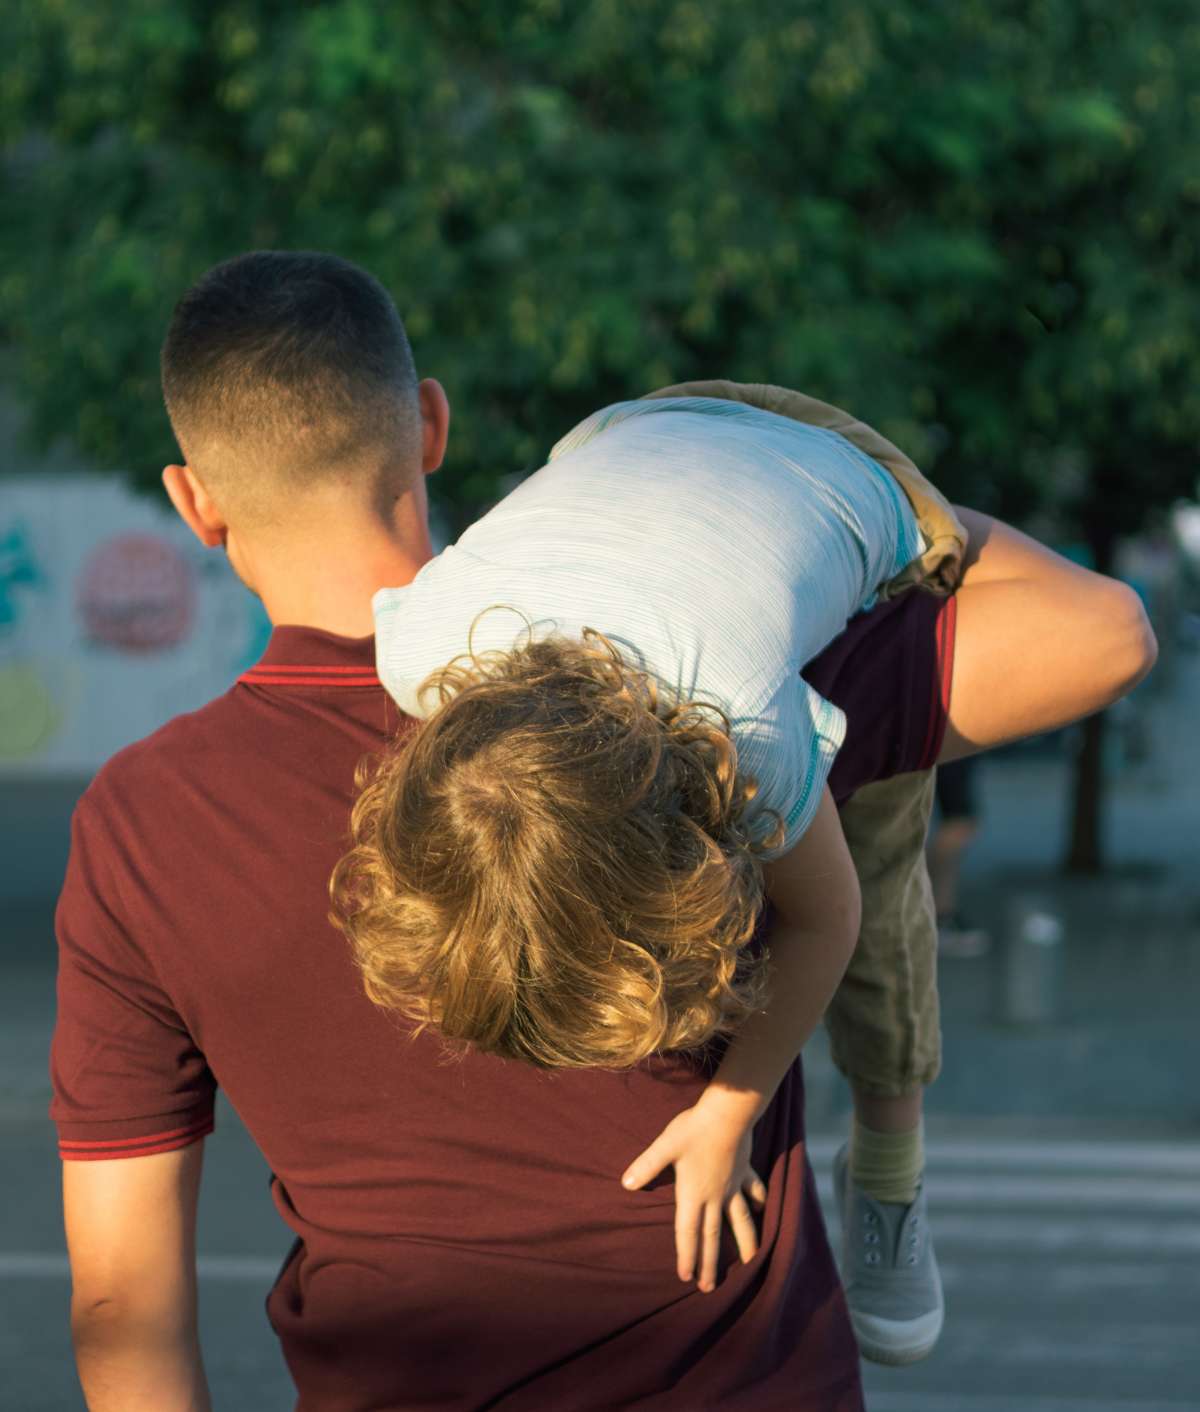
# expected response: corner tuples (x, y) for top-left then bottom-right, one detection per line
(162, 250), (419, 510)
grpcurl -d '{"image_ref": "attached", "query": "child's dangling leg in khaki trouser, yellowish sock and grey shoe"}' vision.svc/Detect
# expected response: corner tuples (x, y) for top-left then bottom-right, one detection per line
(826, 770), (943, 1363)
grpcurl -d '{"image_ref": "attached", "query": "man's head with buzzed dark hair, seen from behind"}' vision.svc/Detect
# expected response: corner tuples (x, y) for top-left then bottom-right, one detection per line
(162, 250), (449, 629)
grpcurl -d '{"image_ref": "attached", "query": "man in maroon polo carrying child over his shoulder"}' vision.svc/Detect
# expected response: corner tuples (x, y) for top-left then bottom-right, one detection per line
(52, 253), (1149, 1412)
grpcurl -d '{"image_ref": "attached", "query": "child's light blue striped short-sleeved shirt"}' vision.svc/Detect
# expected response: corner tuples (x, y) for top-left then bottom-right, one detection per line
(373, 397), (923, 849)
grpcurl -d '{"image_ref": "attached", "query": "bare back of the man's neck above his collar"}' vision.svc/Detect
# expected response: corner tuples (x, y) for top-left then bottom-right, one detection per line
(254, 491), (433, 637)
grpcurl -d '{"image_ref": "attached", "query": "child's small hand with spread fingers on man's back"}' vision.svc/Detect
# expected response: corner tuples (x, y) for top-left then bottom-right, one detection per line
(621, 1089), (767, 1293)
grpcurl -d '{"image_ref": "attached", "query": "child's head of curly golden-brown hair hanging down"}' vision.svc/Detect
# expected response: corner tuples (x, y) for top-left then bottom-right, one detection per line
(332, 634), (765, 1067)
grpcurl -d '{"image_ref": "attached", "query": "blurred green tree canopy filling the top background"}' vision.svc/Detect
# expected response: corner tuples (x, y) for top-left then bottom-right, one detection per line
(0, 0), (1200, 858)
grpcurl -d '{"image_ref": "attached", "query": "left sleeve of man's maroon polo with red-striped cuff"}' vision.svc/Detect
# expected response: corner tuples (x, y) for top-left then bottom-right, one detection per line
(49, 794), (216, 1162)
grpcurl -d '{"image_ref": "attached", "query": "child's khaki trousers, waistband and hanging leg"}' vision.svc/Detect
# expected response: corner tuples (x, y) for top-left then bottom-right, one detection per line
(649, 381), (967, 1097)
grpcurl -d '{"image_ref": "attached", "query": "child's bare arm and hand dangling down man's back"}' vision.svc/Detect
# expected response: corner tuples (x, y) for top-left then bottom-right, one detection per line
(621, 789), (860, 1291)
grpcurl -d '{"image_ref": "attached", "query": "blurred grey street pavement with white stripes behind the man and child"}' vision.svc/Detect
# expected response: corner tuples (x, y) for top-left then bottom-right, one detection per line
(0, 659), (1200, 1412)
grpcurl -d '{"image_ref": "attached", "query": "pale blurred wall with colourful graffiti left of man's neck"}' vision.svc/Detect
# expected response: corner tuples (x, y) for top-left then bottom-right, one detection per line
(0, 476), (270, 774)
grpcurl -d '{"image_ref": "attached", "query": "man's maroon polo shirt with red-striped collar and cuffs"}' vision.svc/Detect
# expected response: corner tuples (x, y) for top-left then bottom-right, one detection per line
(51, 594), (953, 1412)
